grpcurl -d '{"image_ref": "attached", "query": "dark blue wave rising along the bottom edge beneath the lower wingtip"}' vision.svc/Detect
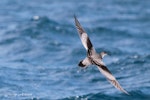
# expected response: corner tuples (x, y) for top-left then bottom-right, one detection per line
(58, 90), (150, 100)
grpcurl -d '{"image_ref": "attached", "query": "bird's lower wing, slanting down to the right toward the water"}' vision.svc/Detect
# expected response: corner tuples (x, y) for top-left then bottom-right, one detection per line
(94, 62), (129, 95)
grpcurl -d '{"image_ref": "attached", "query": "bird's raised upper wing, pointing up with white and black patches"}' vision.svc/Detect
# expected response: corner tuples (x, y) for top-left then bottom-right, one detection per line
(74, 16), (95, 52)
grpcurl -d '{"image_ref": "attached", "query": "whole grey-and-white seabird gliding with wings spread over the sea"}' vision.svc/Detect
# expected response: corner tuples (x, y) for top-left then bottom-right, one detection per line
(74, 16), (128, 94)
